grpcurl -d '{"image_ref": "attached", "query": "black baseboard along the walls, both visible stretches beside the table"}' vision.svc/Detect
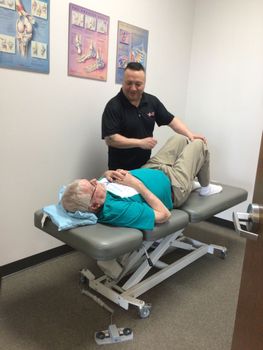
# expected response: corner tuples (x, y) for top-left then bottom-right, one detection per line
(0, 217), (234, 283)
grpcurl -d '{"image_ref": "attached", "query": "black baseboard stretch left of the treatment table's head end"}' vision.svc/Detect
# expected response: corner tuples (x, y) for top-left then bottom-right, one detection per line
(0, 244), (73, 278)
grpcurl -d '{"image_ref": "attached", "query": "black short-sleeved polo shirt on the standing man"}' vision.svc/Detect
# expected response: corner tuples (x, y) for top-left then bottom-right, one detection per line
(102, 90), (173, 170)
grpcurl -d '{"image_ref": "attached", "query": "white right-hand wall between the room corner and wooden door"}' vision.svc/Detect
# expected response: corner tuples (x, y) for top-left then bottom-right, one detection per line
(186, 0), (263, 219)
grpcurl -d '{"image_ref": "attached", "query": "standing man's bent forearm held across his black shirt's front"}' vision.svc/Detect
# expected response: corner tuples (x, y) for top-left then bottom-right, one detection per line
(105, 134), (157, 149)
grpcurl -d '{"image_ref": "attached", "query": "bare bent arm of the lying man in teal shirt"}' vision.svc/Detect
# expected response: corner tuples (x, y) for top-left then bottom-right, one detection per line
(116, 172), (171, 224)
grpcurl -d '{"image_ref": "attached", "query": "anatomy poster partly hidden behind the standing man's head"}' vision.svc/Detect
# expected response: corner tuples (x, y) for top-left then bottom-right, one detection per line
(116, 21), (149, 84)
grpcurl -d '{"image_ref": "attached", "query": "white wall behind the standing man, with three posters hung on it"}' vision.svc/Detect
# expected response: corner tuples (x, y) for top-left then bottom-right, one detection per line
(0, 0), (194, 265)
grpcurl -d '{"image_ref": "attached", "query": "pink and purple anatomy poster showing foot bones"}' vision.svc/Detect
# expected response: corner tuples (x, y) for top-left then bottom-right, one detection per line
(68, 4), (110, 81)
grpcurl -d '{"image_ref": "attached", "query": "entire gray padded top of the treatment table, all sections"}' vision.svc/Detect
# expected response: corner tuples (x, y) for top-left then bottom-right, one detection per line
(34, 185), (247, 260)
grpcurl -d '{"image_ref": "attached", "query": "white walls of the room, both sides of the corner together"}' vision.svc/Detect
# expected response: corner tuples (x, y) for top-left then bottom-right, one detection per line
(0, 0), (263, 265)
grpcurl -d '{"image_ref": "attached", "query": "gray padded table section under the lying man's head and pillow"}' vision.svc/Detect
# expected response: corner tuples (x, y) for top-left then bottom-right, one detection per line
(34, 210), (143, 260)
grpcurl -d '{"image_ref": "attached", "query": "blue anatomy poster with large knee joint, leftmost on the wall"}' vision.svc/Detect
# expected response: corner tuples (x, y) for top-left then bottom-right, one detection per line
(0, 0), (49, 73)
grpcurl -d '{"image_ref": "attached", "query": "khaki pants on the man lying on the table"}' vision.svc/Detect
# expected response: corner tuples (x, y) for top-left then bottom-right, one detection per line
(143, 134), (210, 208)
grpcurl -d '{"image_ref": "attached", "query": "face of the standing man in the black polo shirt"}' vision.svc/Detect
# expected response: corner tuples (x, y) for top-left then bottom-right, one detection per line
(122, 69), (145, 107)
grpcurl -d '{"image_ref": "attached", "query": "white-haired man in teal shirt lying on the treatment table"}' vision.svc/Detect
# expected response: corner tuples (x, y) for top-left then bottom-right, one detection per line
(61, 135), (222, 230)
